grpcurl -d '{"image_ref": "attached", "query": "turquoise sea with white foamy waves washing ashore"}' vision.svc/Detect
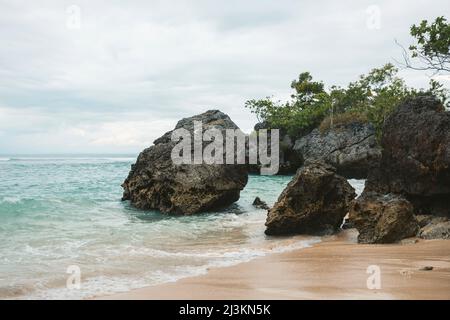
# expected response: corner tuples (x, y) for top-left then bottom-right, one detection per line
(0, 156), (360, 299)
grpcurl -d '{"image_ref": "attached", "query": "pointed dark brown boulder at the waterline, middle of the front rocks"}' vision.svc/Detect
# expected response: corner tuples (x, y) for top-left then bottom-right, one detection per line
(266, 163), (356, 235)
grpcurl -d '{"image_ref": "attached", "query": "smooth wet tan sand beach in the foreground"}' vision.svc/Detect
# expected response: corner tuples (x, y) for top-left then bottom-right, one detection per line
(97, 230), (450, 300)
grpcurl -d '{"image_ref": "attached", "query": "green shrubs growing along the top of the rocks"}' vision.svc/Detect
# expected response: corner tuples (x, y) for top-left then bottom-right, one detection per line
(245, 63), (449, 141)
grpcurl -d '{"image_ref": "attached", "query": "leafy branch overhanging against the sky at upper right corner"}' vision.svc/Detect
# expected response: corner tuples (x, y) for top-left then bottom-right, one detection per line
(402, 16), (450, 74)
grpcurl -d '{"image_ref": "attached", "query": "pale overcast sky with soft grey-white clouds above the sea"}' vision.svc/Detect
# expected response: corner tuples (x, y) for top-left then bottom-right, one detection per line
(0, 0), (450, 154)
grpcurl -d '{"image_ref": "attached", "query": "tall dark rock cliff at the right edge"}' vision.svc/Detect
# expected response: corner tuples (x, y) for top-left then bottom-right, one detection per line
(366, 96), (450, 215)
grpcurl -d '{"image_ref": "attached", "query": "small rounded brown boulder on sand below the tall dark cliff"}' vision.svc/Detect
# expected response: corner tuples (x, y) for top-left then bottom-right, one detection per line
(349, 192), (419, 243)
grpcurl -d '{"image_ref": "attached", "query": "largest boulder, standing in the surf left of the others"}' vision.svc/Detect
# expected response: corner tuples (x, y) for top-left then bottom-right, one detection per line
(122, 110), (248, 214)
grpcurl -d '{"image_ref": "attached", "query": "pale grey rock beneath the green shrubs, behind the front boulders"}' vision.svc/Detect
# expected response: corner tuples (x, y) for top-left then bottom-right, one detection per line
(293, 122), (381, 179)
